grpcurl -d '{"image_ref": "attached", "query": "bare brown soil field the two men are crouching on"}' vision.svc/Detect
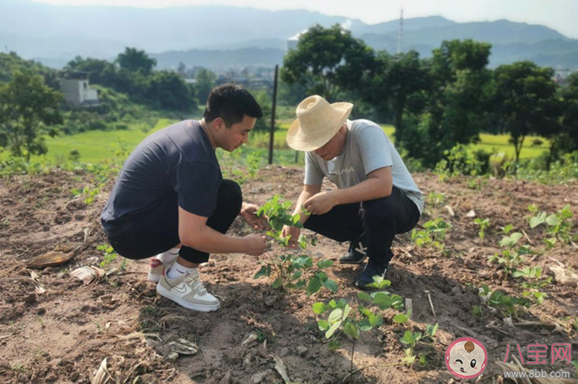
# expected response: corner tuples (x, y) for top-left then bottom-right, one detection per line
(0, 166), (578, 384)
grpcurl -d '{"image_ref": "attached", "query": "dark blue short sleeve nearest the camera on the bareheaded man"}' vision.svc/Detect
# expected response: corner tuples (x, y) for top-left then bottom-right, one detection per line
(175, 161), (222, 217)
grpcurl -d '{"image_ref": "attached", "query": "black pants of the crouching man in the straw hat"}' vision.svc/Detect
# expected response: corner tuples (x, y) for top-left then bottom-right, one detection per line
(305, 187), (420, 265)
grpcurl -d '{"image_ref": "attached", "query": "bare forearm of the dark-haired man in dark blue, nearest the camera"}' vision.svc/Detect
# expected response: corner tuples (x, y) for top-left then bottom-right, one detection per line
(179, 207), (266, 255)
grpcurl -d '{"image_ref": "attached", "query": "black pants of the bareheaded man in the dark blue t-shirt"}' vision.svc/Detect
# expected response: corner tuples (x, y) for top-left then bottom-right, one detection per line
(109, 180), (243, 263)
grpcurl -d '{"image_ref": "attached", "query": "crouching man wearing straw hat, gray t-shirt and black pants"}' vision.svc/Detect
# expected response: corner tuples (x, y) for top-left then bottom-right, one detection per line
(283, 95), (423, 289)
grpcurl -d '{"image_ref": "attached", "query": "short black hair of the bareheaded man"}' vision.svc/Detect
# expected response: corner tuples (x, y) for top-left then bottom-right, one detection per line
(203, 84), (263, 127)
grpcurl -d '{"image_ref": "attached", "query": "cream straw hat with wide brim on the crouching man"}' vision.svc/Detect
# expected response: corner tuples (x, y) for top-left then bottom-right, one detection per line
(287, 95), (353, 152)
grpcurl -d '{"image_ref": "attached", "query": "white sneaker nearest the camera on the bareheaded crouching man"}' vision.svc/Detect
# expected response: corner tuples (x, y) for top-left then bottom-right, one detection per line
(157, 267), (221, 312)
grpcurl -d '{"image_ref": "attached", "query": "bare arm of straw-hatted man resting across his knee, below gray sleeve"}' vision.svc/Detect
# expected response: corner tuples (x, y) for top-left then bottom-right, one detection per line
(304, 167), (393, 215)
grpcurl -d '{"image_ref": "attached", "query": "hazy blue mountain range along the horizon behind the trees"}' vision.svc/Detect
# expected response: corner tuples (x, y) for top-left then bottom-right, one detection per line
(0, 0), (578, 69)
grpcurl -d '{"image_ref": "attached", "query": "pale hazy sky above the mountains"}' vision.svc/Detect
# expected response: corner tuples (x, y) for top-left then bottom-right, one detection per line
(20, 0), (578, 38)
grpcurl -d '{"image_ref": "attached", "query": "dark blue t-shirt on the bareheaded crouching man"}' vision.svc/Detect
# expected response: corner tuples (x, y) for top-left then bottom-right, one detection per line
(101, 120), (223, 236)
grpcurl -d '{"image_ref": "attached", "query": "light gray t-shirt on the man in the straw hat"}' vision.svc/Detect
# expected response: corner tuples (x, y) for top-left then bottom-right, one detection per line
(305, 120), (424, 214)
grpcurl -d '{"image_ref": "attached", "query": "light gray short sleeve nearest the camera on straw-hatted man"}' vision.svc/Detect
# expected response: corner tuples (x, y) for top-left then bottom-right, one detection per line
(357, 126), (393, 175)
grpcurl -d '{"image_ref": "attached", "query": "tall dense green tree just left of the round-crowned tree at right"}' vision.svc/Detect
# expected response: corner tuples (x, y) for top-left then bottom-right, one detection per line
(403, 40), (491, 167)
